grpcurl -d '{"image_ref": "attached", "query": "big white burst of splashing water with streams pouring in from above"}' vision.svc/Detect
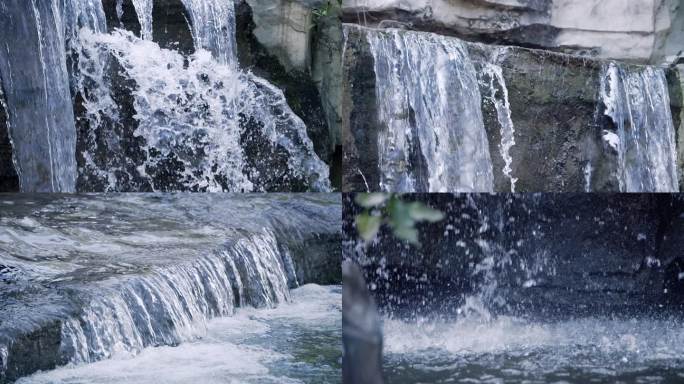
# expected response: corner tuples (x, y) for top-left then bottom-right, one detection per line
(74, 0), (330, 192)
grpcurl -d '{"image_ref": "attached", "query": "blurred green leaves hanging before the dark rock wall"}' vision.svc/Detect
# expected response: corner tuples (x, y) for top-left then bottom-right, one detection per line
(355, 193), (444, 246)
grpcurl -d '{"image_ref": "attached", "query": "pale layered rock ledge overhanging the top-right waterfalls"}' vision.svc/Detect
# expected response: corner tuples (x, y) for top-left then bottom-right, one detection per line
(343, 0), (682, 63)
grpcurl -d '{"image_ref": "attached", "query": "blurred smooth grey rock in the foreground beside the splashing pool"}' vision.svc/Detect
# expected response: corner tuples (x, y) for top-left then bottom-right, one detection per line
(342, 260), (383, 384)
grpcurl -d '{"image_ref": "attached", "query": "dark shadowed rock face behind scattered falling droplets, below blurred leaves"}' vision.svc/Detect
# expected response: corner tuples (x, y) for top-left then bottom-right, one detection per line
(344, 194), (684, 320)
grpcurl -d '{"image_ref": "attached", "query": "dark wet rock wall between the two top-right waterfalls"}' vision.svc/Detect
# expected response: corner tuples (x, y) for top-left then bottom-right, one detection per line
(469, 44), (618, 192)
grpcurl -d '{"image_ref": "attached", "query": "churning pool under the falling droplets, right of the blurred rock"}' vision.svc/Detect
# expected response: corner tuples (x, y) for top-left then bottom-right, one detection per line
(384, 317), (684, 383)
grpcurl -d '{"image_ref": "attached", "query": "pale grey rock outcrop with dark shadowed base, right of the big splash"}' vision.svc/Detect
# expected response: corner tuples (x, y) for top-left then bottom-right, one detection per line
(236, 0), (342, 188)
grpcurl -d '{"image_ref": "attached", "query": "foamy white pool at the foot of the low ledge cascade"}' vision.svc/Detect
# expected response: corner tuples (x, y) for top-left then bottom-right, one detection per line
(18, 285), (342, 384)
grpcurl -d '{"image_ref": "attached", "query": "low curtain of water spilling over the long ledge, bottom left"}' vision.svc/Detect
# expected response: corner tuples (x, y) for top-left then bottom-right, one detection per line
(0, 195), (341, 382)
